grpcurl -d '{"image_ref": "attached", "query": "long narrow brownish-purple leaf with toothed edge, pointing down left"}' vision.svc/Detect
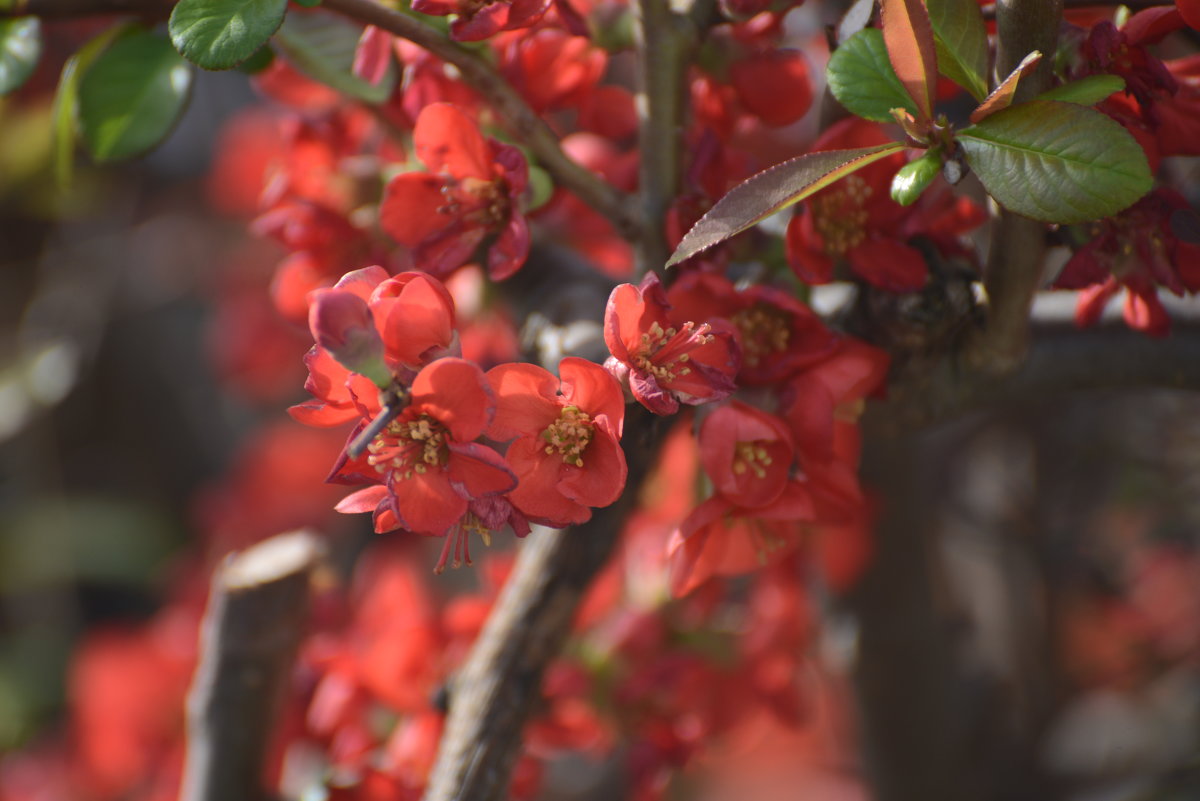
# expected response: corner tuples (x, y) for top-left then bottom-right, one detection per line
(666, 141), (905, 267)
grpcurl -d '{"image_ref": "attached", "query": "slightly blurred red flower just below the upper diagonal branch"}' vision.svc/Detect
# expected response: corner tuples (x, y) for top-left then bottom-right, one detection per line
(379, 103), (529, 281)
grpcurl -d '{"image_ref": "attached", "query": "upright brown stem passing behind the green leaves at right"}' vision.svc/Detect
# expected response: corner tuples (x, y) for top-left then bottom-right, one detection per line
(966, 0), (1062, 375)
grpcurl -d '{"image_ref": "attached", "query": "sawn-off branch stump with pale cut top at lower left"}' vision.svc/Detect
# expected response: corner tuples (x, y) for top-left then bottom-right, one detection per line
(180, 531), (322, 801)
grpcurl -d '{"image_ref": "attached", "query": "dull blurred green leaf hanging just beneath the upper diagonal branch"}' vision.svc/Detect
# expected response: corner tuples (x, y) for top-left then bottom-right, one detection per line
(275, 11), (400, 103)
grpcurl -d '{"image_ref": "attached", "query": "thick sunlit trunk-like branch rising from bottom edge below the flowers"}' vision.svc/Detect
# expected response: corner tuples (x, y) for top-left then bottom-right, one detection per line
(425, 406), (660, 801)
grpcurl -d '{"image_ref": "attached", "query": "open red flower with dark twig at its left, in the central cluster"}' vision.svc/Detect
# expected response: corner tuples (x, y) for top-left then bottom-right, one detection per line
(332, 359), (516, 546)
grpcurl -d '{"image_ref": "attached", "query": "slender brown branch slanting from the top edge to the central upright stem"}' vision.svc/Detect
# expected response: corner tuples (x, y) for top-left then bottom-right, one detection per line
(322, 0), (641, 242)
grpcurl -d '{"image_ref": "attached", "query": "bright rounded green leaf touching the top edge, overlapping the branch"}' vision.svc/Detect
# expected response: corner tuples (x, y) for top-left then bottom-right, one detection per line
(167, 0), (288, 70)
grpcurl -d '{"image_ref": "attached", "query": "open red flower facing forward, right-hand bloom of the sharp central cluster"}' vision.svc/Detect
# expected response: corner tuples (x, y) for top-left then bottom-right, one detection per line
(487, 357), (628, 526)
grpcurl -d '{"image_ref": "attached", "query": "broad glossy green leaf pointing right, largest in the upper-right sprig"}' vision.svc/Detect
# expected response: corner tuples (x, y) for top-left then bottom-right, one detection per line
(956, 101), (1153, 223)
